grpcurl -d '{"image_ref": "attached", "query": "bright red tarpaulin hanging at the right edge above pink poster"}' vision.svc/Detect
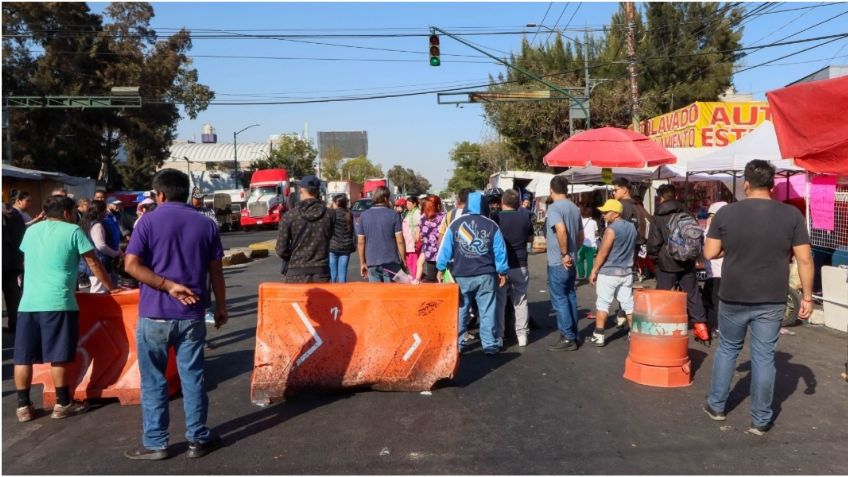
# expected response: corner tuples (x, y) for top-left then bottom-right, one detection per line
(766, 76), (848, 175)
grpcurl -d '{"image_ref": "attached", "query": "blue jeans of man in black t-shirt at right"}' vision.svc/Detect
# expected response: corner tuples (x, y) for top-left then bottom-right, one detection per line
(707, 301), (786, 426)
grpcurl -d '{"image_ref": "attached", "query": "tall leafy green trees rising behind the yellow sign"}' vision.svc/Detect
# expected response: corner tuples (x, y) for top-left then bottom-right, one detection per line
(484, 2), (743, 162)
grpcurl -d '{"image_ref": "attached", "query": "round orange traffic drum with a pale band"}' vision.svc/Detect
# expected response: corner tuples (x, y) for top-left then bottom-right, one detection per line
(624, 289), (692, 388)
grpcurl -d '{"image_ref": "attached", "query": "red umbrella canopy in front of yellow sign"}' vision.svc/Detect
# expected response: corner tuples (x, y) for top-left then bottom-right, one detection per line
(544, 127), (677, 168)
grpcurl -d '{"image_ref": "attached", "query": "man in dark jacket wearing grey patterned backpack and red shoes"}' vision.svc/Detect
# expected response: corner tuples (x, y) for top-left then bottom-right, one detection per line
(647, 184), (710, 346)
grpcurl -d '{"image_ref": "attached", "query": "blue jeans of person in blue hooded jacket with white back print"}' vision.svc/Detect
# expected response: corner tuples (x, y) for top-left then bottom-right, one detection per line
(454, 274), (503, 350)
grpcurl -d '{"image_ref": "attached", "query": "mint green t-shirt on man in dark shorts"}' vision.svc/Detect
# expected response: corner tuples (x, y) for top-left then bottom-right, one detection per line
(18, 220), (94, 311)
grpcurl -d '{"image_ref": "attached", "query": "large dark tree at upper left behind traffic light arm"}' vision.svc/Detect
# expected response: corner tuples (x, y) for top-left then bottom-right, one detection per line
(3, 2), (214, 188)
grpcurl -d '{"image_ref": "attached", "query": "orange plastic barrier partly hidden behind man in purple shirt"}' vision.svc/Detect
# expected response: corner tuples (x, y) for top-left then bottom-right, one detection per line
(32, 290), (180, 407)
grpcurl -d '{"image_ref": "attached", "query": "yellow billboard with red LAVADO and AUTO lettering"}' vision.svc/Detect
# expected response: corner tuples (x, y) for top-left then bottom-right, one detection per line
(640, 101), (771, 148)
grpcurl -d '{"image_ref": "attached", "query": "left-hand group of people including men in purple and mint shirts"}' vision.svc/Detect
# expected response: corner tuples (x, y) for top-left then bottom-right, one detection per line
(3, 169), (228, 460)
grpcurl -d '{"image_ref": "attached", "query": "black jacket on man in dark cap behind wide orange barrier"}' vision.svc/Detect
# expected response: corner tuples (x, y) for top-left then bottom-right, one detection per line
(276, 199), (335, 275)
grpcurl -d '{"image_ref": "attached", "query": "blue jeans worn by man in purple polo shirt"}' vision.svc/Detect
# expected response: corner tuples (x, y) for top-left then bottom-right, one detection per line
(136, 317), (210, 450)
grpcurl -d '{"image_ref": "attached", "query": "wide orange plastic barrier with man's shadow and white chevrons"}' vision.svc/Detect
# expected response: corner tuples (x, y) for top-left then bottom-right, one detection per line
(250, 283), (459, 406)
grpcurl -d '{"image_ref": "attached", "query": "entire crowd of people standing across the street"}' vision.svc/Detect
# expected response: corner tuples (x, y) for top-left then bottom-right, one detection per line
(3, 161), (813, 452)
